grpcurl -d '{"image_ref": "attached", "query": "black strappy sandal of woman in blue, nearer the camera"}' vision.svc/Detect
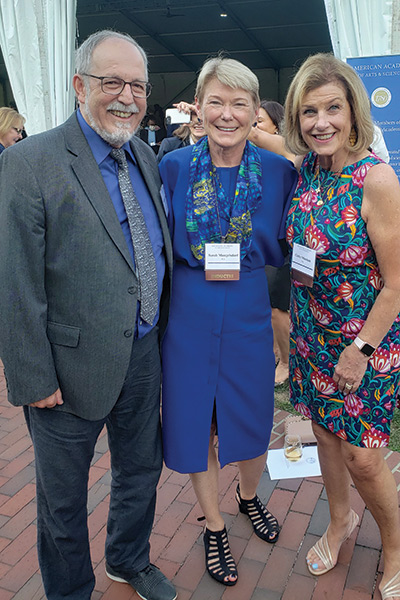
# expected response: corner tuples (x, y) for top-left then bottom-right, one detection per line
(204, 527), (238, 585)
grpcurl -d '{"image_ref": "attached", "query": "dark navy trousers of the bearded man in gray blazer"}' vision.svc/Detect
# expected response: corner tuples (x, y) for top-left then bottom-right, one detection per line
(25, 330), (162, 600)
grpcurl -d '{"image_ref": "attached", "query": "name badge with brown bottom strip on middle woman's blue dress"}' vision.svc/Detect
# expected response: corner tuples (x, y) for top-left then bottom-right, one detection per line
(204, 244), (240, 281)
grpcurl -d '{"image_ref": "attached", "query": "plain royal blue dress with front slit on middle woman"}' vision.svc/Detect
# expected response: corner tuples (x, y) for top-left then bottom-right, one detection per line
(160, 146), (298, 473)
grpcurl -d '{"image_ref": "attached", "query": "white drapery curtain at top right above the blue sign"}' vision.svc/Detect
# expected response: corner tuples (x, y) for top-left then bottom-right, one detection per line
(325, 0), (400, 60)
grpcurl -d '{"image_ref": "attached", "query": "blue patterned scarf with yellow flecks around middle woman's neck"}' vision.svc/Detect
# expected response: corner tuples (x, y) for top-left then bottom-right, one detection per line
(186, 137), (262, 264)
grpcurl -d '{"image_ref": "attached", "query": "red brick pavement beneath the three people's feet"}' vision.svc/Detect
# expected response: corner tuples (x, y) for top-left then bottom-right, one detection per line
(0, 360), (400, 600)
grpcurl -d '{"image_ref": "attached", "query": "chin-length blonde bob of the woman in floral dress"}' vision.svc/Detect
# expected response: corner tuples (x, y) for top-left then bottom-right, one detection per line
(284, 53), (374, 155)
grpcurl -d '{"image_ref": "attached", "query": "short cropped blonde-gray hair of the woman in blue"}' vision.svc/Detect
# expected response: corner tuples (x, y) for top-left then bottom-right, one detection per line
(196, 56), (260, 108)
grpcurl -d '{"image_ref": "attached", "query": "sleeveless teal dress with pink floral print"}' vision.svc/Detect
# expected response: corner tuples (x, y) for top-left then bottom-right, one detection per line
(287, 153), (400, 447)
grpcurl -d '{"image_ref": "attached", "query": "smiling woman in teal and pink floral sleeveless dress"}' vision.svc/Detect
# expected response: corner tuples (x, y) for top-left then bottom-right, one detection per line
(285, 54), (400, 600)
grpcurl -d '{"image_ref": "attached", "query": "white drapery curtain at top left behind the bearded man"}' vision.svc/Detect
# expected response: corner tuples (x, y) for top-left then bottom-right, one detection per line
(0, 0), (76, 134)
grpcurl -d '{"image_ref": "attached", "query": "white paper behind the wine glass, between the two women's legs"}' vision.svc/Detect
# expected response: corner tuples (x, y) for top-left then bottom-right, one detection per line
(267, 444), (321, 479)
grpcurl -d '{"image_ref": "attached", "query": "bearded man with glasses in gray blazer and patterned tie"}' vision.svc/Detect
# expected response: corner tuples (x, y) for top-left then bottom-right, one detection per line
(0, 31), (176, 600)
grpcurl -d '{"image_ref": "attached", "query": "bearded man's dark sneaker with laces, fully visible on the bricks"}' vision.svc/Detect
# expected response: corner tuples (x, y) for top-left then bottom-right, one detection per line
(106, 563), (178, 600)
